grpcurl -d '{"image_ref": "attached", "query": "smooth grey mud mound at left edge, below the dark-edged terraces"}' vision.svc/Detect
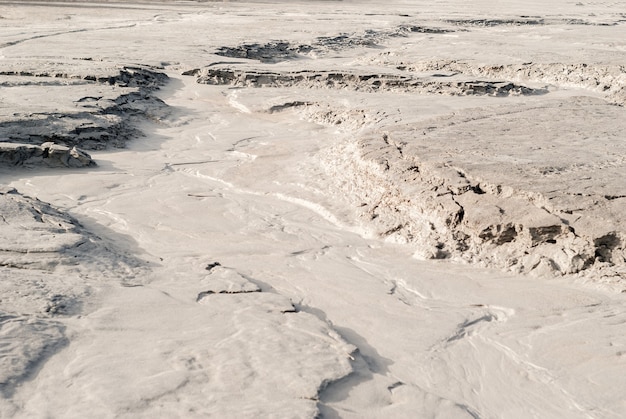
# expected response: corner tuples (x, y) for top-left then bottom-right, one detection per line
(0, 188), (141, 399)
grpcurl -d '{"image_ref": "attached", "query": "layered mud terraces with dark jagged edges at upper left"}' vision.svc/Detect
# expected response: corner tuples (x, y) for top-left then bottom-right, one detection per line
(0, 66), (169, 167)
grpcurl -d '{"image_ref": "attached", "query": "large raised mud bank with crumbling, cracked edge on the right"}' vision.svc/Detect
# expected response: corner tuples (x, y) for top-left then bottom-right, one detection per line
(316, 98), (626, 281)
